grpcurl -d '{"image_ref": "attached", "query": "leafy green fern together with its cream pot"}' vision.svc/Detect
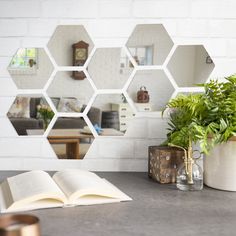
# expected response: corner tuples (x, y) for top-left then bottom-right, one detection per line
(163, 75), (236, 191)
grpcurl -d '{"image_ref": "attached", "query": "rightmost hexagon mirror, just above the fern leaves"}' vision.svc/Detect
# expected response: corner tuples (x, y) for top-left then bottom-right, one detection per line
(167, 45), (215, 87)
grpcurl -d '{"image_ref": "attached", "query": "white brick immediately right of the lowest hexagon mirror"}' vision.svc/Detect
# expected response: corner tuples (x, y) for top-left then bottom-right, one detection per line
(98, 137), (134, 158)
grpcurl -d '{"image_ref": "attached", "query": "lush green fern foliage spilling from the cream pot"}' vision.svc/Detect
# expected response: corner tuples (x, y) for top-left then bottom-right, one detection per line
(165, 75), (236, 153)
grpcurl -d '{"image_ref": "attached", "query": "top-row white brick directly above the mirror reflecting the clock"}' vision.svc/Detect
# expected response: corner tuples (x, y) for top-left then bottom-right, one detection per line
(42, 0), (98, 18)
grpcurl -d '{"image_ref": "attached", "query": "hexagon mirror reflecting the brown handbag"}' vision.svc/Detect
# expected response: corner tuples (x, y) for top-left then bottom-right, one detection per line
(127, 70), (174, 112)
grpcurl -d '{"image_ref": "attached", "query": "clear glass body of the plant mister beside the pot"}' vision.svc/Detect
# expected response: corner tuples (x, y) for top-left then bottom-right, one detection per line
(176, 159), (203, 191)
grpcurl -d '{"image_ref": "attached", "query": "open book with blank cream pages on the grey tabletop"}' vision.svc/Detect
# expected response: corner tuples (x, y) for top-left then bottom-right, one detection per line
(0, 170), (132, 213)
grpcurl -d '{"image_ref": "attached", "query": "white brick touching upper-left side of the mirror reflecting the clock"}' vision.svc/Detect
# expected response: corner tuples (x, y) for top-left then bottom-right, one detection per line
(28, 19), (58, 37)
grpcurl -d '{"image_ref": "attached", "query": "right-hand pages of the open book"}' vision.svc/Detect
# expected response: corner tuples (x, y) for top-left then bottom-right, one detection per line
(53, 170), (131, 204)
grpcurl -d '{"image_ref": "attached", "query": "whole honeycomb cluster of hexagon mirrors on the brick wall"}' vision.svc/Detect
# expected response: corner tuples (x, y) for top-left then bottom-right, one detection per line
(7, 24), (214, 159)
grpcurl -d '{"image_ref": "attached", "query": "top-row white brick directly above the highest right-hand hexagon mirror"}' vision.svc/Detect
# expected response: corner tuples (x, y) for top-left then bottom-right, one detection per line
(133, 0), (189, 18)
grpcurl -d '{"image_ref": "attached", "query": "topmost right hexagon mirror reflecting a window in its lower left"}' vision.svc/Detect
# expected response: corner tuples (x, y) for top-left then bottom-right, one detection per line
(126, 24), (174, 66)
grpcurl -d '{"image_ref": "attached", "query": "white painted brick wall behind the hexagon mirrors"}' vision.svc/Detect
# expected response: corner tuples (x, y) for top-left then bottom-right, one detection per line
(0, 0), (236, 171)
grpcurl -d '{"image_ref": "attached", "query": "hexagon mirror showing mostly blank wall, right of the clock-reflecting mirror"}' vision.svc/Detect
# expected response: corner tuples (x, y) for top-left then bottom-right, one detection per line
(88, 48), (134, 89)
